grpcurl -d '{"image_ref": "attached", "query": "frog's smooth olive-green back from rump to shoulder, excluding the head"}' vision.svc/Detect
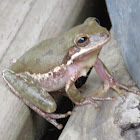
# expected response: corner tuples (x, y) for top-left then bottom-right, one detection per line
(10, 38), (70, 73)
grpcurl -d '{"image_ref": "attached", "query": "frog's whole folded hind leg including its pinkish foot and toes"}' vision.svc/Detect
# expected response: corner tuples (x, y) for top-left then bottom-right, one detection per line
(3, 70), (71, 129)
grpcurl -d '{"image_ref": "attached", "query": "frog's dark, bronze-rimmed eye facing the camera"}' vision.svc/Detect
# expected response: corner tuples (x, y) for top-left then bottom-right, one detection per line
(75, 34), (89, 47)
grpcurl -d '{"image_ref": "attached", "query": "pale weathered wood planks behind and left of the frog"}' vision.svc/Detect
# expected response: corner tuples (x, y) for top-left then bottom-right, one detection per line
(0, 0), (85, 140)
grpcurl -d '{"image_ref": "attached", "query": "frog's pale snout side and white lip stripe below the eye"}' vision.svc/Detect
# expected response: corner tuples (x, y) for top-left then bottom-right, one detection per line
(67, 32), (110, 65)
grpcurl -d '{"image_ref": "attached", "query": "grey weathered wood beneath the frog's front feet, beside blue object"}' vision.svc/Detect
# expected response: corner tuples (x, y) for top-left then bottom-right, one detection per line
(59, 29), (140, 140)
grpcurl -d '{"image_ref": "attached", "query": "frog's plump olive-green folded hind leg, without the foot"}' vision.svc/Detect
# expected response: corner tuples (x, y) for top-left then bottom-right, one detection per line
(3, 70), (56, 113)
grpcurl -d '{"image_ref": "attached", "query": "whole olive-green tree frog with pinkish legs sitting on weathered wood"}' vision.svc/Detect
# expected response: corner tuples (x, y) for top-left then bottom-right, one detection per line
(3, 17), (139, 129)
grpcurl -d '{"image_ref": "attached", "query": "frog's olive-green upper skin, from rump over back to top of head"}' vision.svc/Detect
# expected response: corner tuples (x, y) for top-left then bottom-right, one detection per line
(10, 18), (106, 73)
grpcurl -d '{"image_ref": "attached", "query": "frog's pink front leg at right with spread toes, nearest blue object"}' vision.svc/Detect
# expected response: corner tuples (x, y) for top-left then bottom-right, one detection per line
(94, 58), (140, 96)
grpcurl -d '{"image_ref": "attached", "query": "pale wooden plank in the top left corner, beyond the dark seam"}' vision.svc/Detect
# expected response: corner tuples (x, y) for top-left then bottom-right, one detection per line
(0, 0), (34, 61)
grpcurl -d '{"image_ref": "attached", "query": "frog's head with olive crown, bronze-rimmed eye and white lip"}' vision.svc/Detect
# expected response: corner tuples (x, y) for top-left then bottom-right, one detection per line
(69, 17), (110, 63)
